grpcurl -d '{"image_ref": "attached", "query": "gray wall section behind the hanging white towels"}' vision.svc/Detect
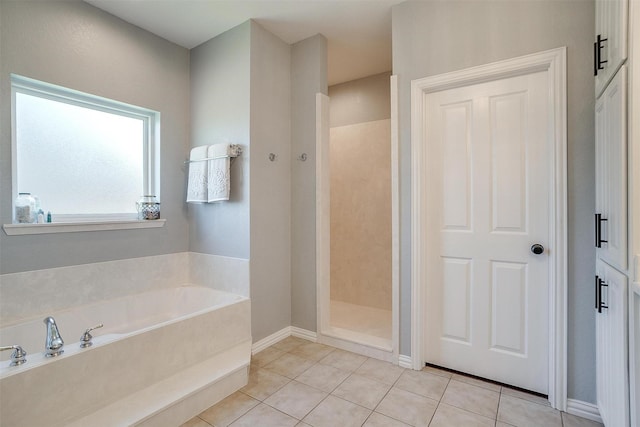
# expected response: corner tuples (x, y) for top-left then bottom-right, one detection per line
(187, 21), (251, 259)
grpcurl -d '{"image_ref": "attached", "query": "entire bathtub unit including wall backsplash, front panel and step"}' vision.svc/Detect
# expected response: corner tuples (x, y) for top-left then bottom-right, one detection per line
(0, 253), (252, 427)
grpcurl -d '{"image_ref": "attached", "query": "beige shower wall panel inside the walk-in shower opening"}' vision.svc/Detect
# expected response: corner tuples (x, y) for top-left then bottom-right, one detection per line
(330, 119), (391, 310)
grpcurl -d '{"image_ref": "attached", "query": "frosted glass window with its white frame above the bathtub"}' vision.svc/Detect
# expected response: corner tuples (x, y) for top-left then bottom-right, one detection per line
(11, 75), (160, 222)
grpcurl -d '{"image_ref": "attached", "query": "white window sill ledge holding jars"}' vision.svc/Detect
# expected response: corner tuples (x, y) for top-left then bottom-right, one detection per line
(2, 219), (166, 236)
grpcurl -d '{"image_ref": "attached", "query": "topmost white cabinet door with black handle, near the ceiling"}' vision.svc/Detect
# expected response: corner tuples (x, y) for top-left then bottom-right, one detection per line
(593, 0), (629, 98)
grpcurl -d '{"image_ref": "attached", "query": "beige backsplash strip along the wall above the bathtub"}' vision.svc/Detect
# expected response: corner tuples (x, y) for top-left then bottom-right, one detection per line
(0, 252), (249, 328)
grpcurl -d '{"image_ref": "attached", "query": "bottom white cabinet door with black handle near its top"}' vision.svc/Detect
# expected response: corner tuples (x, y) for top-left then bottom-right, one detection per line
(595, 260), (629, 427)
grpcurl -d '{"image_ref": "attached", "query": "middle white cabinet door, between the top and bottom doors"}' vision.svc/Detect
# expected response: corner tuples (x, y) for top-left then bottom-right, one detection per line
(594, 65), (628, 270)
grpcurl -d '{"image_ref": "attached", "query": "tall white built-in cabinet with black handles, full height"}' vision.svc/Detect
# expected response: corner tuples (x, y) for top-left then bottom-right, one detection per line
(594, 0), (640, 427)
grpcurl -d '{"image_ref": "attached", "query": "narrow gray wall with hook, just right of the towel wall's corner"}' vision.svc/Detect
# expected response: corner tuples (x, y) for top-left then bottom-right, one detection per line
(250, 22), (291, 342)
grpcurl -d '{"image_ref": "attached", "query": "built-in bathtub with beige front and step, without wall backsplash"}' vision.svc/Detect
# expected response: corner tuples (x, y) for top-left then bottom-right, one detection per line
(0, 286), (251, 427)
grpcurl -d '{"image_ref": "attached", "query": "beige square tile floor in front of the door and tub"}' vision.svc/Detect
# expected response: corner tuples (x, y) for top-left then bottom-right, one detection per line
(182, 337), (601, 427)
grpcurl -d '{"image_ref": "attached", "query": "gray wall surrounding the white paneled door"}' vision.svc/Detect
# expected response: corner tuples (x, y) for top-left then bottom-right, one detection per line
(393, 0), (595, 402)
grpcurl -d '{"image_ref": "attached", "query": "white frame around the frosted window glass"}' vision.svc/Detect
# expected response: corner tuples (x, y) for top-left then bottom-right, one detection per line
(10, 74), (164, 225)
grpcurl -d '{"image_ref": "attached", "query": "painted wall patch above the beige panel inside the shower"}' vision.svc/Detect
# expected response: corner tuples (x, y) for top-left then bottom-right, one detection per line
(329, 72), (391, 127)
